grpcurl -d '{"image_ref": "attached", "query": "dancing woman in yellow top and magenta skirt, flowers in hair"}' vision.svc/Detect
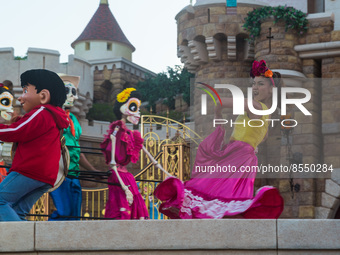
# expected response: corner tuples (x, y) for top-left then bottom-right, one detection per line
(154, 60), (283, 219)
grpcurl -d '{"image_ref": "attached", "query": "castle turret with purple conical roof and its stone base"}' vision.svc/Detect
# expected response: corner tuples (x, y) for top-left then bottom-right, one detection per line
(71, 0), (155, 103)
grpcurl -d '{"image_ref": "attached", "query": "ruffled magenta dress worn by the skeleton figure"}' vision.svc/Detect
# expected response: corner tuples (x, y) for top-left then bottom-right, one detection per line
(100, 120), (149, 220)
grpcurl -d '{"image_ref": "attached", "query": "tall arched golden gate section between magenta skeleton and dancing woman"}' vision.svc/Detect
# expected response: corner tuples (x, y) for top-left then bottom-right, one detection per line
(135, 115), (201, 219)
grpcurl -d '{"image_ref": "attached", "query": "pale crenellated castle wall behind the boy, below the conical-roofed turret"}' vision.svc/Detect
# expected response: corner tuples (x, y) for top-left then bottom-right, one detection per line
(0, 48), (155, 119)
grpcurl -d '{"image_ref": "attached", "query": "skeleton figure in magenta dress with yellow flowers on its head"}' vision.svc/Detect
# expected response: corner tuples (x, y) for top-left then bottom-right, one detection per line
(101, 88), (149, 220)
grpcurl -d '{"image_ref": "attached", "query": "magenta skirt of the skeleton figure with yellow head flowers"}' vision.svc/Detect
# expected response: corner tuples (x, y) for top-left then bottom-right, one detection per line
(105, 172), (149, 220)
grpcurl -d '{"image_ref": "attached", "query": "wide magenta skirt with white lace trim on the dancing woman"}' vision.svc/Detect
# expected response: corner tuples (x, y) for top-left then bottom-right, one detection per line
(154, 127), (284, 219)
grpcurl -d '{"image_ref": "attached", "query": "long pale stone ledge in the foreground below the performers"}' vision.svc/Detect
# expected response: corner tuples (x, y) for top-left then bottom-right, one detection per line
(0, 219), (340, 254)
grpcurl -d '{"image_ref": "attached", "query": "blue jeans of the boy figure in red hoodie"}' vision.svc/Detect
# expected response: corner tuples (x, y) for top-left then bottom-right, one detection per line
(0, 172), (52, 221)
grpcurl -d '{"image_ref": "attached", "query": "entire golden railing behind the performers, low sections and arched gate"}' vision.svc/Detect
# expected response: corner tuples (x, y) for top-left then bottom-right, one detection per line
(27, 115), (202, 220)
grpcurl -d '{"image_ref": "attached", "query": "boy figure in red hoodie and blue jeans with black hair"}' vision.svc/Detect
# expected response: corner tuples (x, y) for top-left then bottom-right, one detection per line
(0, 69), (69, 221)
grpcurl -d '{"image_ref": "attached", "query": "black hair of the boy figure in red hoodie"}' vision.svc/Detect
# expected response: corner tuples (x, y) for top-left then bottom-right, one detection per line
(20, 69), (66, 107)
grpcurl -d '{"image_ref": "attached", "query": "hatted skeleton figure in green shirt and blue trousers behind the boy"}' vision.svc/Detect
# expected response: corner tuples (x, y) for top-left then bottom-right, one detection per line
(50, 74), (82, 220)
